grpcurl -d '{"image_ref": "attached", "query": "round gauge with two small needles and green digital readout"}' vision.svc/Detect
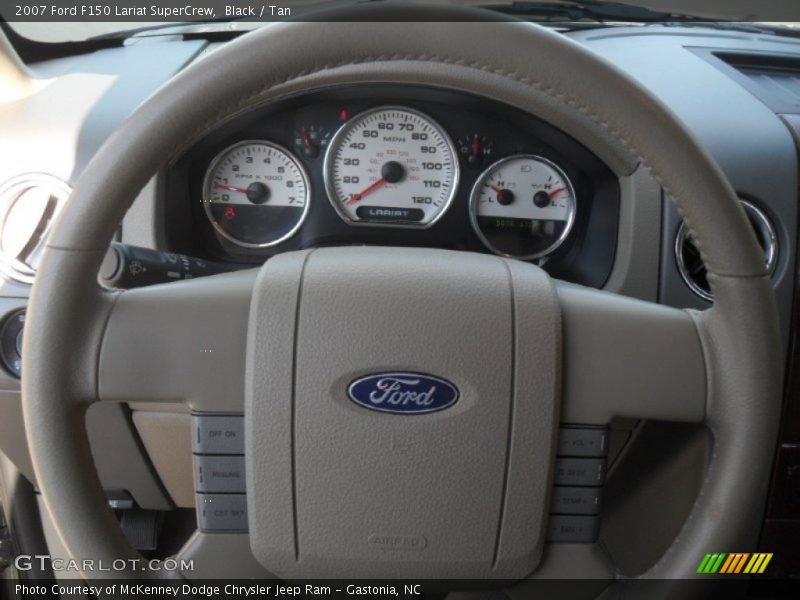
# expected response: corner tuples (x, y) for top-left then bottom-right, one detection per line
(470, 154), (575, 260)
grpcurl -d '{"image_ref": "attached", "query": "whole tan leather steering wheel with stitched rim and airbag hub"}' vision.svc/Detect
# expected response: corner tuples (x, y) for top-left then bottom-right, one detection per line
(23, 8), (781, 596)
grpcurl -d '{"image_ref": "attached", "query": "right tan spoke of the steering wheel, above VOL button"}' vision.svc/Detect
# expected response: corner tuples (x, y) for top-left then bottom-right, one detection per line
(556, 282), (707, 425)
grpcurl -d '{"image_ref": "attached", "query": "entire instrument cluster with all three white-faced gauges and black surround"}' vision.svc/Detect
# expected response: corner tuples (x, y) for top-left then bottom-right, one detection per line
(165, 85), (619, 287)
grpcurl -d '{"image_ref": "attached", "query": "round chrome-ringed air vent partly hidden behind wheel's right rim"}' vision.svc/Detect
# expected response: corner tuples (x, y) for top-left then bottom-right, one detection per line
(675, 200), (778, 302)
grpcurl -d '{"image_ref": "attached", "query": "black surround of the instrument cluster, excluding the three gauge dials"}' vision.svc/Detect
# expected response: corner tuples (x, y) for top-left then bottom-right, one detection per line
(164, 84), (620, 287)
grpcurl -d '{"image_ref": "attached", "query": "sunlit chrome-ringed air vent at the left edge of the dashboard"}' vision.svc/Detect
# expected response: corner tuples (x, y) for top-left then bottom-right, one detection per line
(0, 173), (71, 283)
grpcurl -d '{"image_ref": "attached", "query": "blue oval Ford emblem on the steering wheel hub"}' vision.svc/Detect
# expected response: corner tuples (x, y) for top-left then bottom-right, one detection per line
(347, 372), (458, 415)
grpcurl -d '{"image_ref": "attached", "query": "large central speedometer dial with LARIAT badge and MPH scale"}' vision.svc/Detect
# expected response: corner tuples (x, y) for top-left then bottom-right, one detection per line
(325, 106), (458, 227)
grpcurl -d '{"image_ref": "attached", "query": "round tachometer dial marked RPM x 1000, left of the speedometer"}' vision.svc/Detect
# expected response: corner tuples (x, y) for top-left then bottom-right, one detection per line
(203, 141), (309, 248)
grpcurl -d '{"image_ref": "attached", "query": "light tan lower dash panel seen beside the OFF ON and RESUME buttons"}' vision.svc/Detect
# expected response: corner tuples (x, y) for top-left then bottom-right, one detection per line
(132, 411), (194, 508)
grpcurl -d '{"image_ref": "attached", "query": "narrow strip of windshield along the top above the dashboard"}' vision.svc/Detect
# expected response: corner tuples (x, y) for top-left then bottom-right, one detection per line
(0, 0), (800, 43)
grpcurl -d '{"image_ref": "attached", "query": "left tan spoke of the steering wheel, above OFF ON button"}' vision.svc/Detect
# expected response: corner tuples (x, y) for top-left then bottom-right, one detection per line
(98, 270), (256, 412)
